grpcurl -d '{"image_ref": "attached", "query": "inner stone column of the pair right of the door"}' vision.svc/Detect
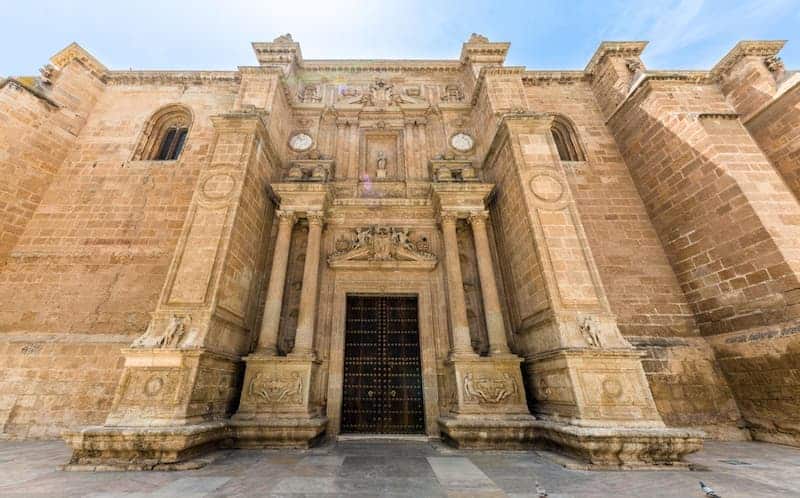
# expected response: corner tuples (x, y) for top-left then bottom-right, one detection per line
(441, 212), (477, 356)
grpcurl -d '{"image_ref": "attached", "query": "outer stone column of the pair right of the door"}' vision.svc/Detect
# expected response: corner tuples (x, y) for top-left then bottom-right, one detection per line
(469, 211), (510, 355)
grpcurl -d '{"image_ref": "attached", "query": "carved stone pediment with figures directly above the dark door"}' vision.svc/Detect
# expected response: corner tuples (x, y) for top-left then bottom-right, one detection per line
(328, 225), (437, 268)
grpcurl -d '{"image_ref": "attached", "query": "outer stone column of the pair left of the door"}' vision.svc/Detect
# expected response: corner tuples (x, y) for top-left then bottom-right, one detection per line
(257, 211), (296, 355)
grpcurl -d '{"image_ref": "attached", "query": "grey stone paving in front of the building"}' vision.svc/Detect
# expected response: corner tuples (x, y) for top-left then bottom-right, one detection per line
(0, 441), (800, 498)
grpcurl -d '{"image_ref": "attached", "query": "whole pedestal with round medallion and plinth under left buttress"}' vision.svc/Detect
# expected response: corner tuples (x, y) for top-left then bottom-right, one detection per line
(64, 349), (240, 470)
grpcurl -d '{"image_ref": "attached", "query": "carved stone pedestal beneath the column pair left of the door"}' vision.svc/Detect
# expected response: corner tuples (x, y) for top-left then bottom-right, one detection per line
(231, 354), (328, 448)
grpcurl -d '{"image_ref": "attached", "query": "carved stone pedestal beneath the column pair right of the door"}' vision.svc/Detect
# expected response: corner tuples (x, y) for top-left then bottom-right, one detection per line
(439, 354), (535, 449)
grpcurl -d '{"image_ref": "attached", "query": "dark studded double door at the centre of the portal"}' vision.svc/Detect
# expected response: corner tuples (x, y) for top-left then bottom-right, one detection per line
(342, 295), (425, 434)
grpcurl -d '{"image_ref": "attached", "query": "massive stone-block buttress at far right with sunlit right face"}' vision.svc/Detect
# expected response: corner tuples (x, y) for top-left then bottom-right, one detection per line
(595, 46), (800, 438)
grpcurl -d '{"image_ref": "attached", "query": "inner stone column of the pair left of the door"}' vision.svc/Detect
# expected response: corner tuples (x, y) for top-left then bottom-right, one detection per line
(292, 212), (323, 356)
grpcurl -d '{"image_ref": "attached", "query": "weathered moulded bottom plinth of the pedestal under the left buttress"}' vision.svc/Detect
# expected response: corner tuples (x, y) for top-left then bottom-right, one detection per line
(64, 421), (230, 471)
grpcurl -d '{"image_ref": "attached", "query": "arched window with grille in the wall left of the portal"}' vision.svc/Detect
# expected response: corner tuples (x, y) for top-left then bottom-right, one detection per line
(133, 105), (192, 161)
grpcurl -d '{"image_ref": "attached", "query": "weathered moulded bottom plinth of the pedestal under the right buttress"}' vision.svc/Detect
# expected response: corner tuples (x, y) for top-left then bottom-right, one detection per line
(534, 420), (705, 470)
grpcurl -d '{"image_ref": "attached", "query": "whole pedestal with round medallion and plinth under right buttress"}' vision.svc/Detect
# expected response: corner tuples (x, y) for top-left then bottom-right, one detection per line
(526, 349), (704, 468)
